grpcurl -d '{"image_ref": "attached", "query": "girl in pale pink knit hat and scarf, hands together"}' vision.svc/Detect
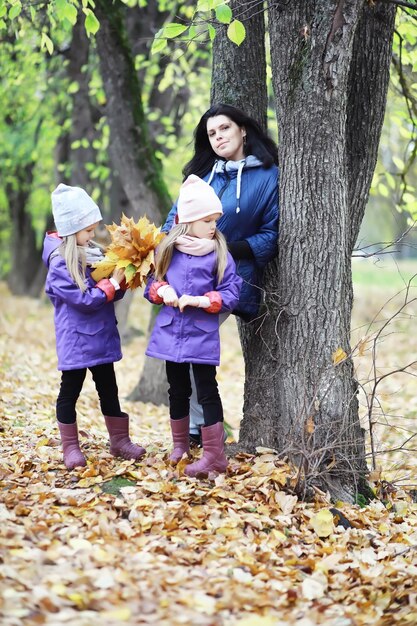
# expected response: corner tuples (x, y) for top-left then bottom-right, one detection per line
(145, 175), (242, 478)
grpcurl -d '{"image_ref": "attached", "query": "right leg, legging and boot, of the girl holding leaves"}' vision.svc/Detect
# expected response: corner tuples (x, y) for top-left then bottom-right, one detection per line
(89, 363), (146, 460)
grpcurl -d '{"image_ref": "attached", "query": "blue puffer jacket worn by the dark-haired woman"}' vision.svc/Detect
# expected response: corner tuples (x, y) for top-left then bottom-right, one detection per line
(162, 156), (279, 320)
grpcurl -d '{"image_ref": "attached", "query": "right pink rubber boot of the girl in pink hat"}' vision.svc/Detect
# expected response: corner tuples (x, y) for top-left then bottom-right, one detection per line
(184, 422), (228, 478)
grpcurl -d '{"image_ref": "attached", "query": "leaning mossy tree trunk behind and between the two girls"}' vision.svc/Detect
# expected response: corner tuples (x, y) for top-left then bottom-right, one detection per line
(96, 0), (171, 404)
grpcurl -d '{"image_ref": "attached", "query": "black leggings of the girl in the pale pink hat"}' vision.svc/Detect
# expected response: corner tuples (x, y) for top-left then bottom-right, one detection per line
(166, 361), (223, 426)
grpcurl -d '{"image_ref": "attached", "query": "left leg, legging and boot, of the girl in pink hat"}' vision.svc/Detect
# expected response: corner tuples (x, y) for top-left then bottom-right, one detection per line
(166, 361), (191, 464)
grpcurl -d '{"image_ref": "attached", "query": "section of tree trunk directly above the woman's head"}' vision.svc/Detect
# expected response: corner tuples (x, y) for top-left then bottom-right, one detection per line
(211, 0), (268, 128)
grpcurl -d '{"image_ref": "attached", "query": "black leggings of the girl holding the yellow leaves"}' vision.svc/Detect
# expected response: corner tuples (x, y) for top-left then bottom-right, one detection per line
(56, 363), (124, 424)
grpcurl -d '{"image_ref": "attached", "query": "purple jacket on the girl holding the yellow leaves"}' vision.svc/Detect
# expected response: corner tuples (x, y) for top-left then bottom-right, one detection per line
(42, 233), (124, 370)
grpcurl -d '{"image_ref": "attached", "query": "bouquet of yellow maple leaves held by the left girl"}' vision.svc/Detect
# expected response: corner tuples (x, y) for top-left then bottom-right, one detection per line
(92, 214), (165, 289)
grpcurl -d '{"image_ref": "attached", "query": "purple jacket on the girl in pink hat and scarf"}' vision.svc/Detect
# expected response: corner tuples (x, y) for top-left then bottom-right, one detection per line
(144, 250), (242, 365)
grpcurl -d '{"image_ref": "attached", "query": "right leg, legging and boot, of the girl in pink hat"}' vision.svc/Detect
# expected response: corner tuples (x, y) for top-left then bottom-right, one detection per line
(184, 364), (228, 478)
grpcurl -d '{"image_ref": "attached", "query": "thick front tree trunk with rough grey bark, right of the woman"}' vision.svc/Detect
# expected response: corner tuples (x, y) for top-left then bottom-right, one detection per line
(234, 0), (392, 499)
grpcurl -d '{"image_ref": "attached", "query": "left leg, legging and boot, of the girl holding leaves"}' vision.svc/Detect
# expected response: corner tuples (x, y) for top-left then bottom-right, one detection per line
(56, 369), (87, 469)
